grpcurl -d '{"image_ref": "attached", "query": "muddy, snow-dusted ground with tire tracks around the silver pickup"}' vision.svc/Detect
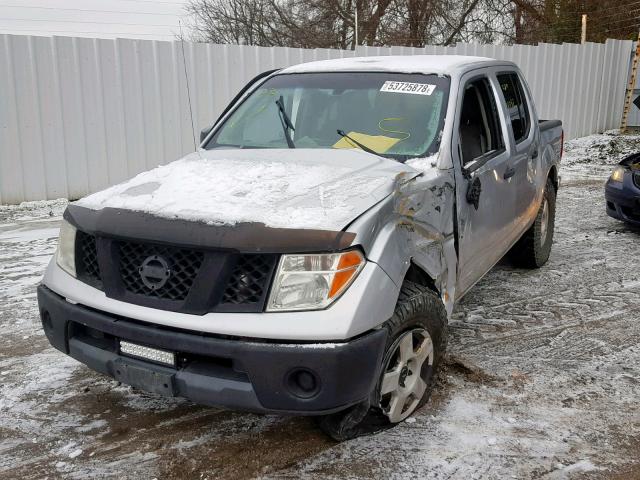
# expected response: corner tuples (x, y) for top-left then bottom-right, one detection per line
(0, 135), (640, 479)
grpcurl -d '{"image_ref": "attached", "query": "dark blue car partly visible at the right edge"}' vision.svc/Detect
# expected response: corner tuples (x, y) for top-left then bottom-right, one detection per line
(605, 153), (640, 226)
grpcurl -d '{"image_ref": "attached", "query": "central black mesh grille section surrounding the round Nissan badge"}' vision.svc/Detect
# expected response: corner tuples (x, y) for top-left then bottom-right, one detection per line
(118, 242), (204, 301)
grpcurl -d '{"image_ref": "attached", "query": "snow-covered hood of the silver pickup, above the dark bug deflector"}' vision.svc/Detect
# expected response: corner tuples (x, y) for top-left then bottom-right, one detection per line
(76, 149), (417, 230)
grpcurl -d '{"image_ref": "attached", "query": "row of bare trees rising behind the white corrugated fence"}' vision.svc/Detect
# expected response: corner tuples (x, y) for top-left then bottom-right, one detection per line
(187, 0), (640, 49)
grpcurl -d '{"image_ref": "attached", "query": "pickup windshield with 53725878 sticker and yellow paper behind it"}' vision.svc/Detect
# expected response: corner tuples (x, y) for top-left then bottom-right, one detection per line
(205, 72), (449, 161)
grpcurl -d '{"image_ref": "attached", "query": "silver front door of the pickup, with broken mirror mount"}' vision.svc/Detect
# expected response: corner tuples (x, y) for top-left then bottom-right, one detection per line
(452, 73), (515, 297)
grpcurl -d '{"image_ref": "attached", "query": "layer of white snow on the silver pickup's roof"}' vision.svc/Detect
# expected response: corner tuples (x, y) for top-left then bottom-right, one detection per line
(280, 55), (507, 74)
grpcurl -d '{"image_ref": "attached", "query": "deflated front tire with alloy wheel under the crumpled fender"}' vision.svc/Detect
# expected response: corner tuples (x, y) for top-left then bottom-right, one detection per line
(317, 282), (447, 441)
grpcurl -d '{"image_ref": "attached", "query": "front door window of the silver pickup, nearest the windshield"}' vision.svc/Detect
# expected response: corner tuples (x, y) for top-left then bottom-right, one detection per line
(459, 78), (504, 165)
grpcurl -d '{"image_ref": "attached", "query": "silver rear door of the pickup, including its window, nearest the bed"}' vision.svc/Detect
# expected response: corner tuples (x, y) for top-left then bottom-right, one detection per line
(496, 71), (540, 235)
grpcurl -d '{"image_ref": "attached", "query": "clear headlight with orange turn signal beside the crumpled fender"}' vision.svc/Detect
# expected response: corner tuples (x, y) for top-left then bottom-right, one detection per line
(267, 250), (365, 311)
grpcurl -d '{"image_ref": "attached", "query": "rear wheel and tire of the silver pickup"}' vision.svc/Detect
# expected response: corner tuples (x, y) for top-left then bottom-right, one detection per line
(509, 178), (556, 268)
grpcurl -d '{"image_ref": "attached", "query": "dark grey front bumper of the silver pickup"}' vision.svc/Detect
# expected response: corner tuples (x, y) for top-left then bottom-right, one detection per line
(38, 285), (387, 415)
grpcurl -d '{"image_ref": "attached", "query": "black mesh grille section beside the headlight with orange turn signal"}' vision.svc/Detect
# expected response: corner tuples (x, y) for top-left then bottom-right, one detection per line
(222, 255), (275, 305)
